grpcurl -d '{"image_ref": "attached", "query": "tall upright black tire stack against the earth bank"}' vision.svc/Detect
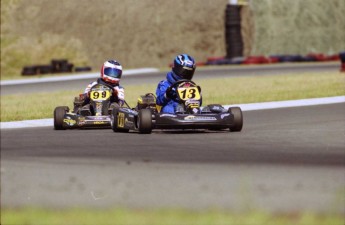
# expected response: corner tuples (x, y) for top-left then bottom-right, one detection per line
(225, 4), (243, 59)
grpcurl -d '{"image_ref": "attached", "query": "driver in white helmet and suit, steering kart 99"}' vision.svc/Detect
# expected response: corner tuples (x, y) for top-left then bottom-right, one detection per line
(74, 60), (125, 112)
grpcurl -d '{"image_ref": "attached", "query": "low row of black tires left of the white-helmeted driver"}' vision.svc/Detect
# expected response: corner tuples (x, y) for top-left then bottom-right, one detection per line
(21, 59), (91, 76)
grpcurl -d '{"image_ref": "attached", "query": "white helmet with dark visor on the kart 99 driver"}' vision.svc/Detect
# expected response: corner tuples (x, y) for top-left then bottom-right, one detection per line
(101, 60), (122, 84)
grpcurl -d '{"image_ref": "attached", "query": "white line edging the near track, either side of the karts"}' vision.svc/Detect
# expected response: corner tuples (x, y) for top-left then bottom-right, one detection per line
(0, 95), (345, 129)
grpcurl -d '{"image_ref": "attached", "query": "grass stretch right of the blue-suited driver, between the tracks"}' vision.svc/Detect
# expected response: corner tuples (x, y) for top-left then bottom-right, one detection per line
(198, 72), (345, 104)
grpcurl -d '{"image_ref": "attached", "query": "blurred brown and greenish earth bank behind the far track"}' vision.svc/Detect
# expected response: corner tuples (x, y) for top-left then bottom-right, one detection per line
(1, 0), (345, 79)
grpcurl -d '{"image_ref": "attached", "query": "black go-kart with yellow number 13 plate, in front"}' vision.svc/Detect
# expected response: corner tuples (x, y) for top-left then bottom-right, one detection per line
(111, 80), (243, 134)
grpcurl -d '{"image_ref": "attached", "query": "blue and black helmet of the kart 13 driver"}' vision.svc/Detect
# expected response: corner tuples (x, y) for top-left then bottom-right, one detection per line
(172, 54), (195, 80)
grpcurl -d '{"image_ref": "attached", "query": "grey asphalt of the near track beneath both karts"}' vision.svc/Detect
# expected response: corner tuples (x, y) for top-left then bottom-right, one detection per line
(1, 62), (345, 213)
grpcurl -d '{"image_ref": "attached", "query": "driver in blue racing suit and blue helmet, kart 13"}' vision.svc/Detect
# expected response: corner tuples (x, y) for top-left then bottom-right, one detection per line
(156, 54), (200, 114)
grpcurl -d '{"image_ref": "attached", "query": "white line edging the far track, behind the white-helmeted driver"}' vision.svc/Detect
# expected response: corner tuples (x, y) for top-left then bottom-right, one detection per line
(0, 68), (159, 86)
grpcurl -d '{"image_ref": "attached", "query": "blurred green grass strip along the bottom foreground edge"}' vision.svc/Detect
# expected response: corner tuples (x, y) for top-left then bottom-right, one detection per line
(1, 208), (344, 225)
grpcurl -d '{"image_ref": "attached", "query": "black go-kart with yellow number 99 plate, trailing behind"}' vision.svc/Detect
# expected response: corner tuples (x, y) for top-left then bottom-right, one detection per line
(54, 84), (119, 130)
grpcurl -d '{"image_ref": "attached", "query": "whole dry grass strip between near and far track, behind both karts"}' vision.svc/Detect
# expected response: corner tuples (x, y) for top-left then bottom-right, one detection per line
(1, 72), (345, 122)
